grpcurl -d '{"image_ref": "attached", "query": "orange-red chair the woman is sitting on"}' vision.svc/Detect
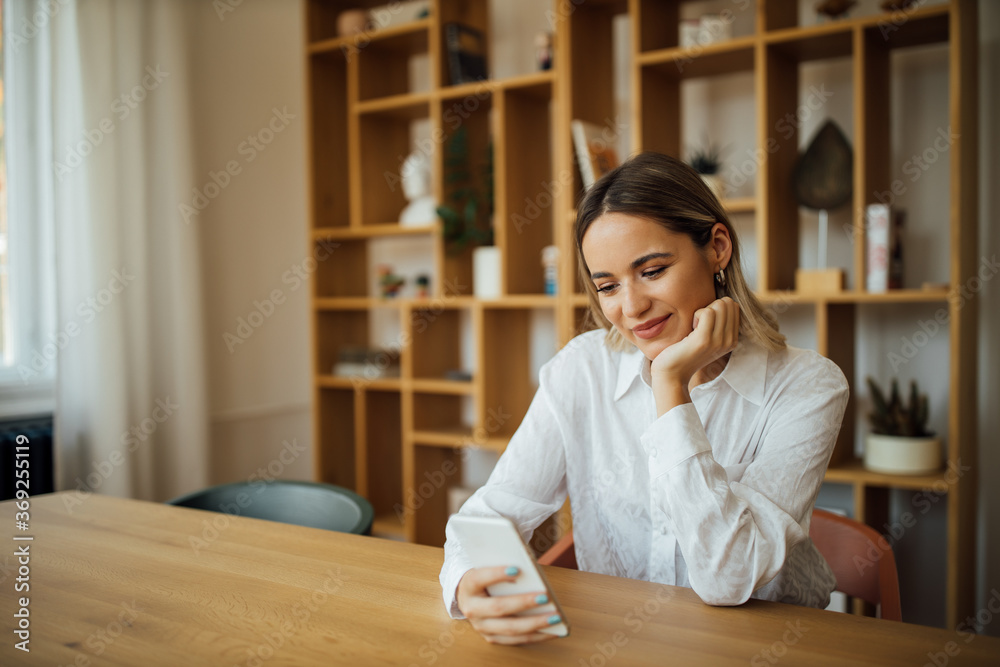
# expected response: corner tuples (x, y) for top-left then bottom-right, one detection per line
(538, 510), (903, 621)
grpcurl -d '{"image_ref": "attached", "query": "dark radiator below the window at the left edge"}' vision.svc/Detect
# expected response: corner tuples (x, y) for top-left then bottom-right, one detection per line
(0, 415), (55, 500)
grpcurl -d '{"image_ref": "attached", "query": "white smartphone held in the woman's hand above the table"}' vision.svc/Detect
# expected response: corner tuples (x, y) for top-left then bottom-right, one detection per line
(451, 514), (569, 637)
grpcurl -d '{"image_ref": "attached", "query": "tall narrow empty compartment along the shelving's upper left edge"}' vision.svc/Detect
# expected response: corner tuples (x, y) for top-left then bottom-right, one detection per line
(308, 55), (350, 228)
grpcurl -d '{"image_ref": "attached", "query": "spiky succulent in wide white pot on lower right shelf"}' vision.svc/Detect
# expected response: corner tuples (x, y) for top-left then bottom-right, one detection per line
(865, 377), (941, 475)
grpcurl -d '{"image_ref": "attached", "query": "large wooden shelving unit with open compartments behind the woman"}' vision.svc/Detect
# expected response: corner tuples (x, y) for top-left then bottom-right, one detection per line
(305, 0), (978, 626)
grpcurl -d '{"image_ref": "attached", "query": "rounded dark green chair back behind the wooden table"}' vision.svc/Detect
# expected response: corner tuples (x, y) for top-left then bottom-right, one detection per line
(167, 480), (375, 535)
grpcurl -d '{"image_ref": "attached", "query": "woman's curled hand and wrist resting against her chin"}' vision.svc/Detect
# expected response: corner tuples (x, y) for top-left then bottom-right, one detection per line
(650, 296), (740, 415)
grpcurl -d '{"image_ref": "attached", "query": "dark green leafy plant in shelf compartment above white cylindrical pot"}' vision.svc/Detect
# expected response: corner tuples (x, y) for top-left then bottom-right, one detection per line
(437, 125), (493, 254)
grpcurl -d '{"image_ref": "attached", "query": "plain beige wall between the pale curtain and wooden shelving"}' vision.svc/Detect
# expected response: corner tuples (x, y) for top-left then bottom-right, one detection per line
(190, 0), (312, 483)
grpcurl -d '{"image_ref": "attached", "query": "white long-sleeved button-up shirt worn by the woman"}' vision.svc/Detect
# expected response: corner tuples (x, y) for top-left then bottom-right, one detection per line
(441, 330), (848, 618)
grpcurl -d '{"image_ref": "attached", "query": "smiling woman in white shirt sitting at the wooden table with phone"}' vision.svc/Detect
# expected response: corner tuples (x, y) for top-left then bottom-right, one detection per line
(441, 153), (848, 644)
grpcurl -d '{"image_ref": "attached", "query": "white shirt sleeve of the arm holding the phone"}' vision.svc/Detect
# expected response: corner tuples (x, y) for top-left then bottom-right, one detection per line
(440, 359), (567, 619)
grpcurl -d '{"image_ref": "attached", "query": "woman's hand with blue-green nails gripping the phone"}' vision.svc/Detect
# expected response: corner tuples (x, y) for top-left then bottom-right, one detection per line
(456, 566), (559, 644)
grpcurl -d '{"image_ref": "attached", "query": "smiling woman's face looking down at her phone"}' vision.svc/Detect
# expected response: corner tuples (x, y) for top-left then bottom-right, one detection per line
(582, 213), (729, 360)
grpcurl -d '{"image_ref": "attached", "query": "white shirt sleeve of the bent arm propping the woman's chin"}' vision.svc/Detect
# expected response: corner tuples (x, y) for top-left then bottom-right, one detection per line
(641, 360), (848, 605)
